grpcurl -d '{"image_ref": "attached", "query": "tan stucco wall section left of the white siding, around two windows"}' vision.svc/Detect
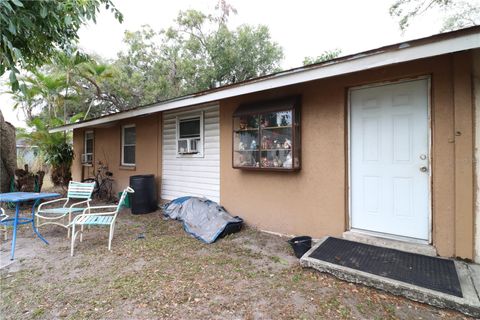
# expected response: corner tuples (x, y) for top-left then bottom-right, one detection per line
(72, 114), (162, 199)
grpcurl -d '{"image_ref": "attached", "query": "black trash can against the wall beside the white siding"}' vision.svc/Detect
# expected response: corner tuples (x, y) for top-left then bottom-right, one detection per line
(129, 174), (158, 214)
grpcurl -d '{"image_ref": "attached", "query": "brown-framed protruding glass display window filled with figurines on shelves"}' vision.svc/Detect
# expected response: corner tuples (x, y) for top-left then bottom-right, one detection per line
(233, 97), (300, 171)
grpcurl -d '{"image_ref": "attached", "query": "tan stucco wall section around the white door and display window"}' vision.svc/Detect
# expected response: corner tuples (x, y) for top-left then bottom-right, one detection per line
(220, 53), (473, 258)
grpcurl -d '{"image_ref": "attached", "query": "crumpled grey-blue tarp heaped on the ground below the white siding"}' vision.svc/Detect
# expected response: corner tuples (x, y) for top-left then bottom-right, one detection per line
(163, 196), (243, 243)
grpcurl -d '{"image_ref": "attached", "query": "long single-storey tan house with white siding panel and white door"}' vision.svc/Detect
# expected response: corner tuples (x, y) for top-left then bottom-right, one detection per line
(51, 27), (480, 262)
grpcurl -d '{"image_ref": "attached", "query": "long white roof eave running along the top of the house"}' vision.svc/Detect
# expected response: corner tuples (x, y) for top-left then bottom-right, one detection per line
(49, 29), (480, 133)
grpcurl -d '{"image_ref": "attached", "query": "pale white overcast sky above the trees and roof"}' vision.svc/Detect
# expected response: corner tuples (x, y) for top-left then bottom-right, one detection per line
(0, 0), (448, 127)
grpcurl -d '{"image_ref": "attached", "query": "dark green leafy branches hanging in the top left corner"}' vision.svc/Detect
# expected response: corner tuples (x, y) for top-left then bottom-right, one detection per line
(0, 0), (123, 91)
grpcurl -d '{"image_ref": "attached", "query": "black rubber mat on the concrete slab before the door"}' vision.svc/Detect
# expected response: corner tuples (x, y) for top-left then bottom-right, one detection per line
(310, 237), (463, 297)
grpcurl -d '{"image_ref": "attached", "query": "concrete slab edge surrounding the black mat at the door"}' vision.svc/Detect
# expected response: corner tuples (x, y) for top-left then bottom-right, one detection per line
(300, 237), (480, 317)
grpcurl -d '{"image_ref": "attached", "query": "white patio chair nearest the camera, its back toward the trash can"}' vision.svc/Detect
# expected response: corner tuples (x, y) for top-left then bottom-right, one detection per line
(70, 187), (135, 257)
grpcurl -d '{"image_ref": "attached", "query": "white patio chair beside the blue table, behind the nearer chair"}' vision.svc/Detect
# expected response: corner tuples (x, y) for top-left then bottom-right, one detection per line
(35, 181), (95, 237)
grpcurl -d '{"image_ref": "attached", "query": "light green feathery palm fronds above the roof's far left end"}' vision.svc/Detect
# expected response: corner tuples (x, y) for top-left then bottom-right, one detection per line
(9, 50), (120, 123)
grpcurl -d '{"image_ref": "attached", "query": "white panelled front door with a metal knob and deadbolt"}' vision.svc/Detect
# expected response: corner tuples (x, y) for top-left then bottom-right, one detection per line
(350, 79), (430, 240)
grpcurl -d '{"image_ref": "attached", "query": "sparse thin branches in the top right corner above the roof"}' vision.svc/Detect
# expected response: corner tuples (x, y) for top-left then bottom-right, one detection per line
(390, 0), (480, 31)
